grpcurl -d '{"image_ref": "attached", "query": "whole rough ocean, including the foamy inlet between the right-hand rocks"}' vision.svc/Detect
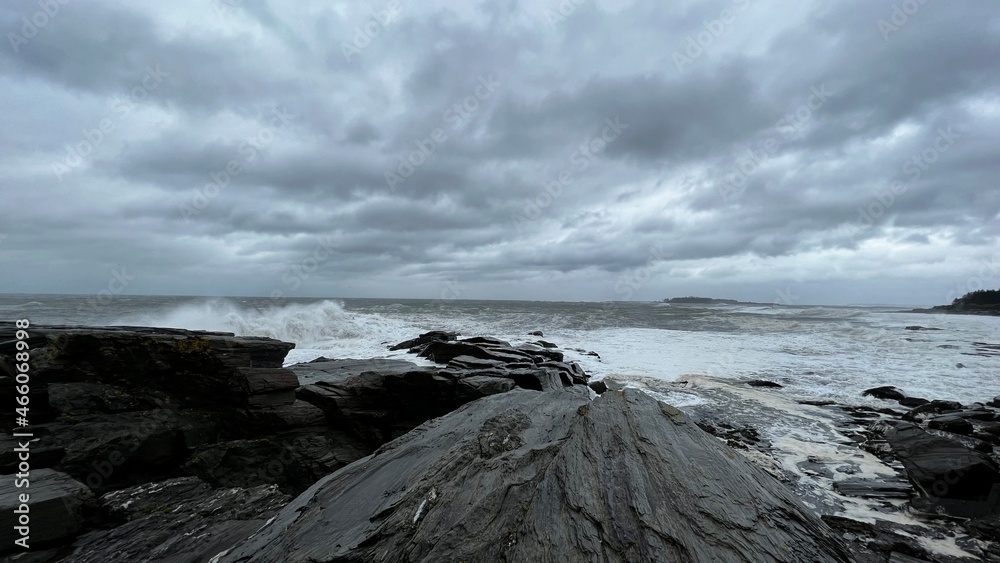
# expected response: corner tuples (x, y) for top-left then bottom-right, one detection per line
(0, 295), (1000, 556)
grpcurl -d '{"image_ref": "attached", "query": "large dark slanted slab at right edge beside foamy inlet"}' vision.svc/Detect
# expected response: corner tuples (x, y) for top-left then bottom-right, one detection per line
(885, 422), (1000, 517)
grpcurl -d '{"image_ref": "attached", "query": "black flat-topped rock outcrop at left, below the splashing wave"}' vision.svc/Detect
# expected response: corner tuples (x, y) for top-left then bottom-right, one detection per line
(0, 323), (356, 495)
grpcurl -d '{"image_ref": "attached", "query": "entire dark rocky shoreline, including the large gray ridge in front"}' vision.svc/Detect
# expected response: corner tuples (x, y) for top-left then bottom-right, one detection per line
(0, 323), (1000, 563)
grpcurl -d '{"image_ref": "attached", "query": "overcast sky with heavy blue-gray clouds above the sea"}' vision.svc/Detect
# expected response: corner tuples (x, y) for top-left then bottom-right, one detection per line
(0, 0), (1000, 304)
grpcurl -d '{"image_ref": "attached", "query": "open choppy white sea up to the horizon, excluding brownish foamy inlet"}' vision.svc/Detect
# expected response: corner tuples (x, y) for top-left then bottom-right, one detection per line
(0, 295), (1000, 406)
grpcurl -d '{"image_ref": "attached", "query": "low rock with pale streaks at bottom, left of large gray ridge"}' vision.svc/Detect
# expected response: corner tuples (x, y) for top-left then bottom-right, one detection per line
(65, 477), (290, 563)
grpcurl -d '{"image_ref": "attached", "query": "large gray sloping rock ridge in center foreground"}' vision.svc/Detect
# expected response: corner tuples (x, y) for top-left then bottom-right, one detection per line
(219, 389), (850, 563)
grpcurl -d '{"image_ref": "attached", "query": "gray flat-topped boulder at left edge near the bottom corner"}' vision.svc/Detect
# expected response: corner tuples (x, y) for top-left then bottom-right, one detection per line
(0, 468), (97, 554)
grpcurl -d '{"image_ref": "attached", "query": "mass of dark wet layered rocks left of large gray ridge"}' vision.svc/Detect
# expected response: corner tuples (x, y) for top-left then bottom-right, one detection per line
(0, 323), (590, 562)
